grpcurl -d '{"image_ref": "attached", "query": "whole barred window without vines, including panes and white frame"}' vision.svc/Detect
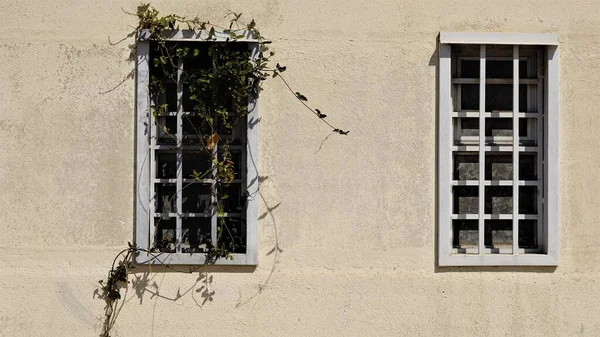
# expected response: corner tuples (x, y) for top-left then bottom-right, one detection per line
(438, 32), (559, 266)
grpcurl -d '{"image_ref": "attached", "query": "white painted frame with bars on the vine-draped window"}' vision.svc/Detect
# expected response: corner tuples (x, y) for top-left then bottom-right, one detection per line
(135, 30), (259, 265)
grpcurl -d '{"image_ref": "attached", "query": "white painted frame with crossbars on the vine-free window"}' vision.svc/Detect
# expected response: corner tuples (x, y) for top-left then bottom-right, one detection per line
(437, 32), (560, 266)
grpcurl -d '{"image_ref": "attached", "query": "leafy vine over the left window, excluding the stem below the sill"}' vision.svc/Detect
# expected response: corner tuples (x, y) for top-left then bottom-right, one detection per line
(136, 4), (349, 257)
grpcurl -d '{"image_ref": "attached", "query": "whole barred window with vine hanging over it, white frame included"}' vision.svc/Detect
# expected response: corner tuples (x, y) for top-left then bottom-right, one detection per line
(135, 31), (258, 265)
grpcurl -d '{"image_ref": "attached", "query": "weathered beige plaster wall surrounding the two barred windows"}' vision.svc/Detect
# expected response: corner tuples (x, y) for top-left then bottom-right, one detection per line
(0, 0), (600, 336)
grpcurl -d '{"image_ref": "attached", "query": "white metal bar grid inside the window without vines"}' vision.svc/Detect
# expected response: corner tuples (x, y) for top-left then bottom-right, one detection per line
(451, 45), (543, 255)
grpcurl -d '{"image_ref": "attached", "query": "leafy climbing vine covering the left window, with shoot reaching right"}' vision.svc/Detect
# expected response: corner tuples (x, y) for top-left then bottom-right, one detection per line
(99, 4), (349, 337)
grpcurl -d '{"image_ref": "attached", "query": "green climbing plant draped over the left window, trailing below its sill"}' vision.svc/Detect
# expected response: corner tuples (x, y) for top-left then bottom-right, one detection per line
(100, 4), (349, 336)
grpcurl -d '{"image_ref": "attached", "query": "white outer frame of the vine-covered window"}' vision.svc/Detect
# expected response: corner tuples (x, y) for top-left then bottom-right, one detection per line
(135, 30), (259, 265)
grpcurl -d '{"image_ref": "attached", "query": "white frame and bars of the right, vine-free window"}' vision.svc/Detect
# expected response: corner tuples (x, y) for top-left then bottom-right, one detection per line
(438, 32), (560, 266)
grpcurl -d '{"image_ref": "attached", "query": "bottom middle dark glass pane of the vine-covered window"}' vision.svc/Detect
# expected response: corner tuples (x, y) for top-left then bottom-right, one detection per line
(181, 218), (212, 253)
